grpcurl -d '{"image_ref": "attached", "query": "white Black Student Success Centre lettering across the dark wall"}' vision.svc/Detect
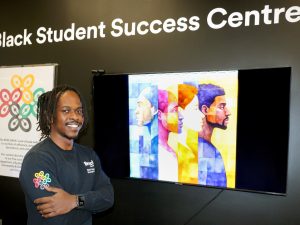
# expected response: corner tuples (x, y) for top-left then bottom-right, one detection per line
(0, 5), (300, 48)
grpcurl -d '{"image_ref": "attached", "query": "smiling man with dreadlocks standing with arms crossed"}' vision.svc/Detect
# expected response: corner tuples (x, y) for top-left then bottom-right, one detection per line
(19, 86), (114, 225)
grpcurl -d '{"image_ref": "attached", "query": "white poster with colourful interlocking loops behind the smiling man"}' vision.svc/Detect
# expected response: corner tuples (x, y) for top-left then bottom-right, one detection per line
(0, 64), (57, 177)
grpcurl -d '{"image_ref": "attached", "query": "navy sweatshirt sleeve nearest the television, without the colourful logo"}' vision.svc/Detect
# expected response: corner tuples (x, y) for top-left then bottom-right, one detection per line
(80, 151), (114, 213)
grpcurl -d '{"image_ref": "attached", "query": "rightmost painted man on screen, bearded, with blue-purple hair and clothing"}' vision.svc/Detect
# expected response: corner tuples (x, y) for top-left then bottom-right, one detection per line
(198, 84), (230, 187)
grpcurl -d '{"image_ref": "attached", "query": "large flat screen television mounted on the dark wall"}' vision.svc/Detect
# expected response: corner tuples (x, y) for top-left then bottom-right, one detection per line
(93, 67), (291, 195)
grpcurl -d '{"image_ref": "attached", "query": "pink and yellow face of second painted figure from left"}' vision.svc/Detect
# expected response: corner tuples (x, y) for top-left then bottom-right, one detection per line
(159, 102), (183, 133)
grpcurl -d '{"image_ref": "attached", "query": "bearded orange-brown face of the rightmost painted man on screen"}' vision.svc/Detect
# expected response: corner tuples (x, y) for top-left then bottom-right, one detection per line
(206, 95), (230, 129)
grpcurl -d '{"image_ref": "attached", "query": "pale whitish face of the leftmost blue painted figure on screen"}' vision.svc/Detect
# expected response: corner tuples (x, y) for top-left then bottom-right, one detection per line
(135, 97), (153, 126)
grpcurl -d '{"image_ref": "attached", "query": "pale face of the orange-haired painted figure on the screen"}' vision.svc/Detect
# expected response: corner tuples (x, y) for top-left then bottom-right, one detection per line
(180, 95), (205, 132)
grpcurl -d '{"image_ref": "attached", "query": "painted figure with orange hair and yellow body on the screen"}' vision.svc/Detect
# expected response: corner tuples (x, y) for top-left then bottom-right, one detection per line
(165, 84), (204, 184)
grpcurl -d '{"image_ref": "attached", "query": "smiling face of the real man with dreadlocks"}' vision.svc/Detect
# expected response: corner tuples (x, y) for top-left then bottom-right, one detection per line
(51, 91), (84, 140)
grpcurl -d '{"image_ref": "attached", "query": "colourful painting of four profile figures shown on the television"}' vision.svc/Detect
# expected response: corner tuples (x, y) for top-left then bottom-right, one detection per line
(129, 71), (238, 188)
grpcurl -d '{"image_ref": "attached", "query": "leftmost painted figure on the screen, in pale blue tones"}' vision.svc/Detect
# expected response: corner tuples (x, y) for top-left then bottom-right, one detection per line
(135, 85), (158, 180)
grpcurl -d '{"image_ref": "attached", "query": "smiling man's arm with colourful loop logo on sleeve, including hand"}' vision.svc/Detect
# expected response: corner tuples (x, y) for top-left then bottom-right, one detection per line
(19, 149), (81, 225)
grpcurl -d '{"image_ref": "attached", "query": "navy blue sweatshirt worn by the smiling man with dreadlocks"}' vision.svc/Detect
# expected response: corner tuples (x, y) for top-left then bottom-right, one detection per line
(19, 138), (114, 225)
